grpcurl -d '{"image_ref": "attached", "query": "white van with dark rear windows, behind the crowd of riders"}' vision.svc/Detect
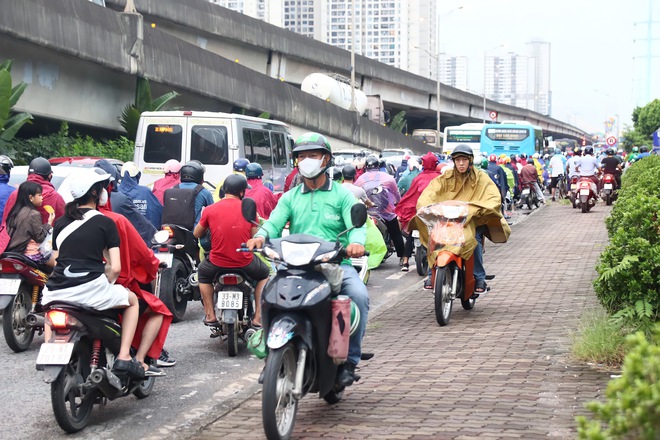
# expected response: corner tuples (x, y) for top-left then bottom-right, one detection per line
(133, 111), (293, 192)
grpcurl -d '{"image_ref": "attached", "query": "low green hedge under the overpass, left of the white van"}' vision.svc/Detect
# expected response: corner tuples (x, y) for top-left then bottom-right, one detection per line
(13, 122), (134, 165)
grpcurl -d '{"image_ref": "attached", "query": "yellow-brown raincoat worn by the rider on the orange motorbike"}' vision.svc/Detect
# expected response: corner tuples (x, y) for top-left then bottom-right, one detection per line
(414, 165), (511, 265)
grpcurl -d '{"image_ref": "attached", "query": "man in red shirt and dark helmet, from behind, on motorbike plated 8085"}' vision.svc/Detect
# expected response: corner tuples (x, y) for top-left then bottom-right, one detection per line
(193, 174), (270, 327)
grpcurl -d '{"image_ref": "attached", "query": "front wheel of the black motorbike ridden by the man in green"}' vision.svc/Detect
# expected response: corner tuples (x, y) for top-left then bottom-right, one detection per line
(261, 342), (298, 440)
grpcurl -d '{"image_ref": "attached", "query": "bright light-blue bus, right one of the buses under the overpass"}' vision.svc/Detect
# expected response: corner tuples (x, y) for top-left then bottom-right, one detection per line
(481, 123), (545, 156)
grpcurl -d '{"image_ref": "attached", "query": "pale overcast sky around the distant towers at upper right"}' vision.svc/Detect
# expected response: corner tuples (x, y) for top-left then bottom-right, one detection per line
(438, 0), (660, 131)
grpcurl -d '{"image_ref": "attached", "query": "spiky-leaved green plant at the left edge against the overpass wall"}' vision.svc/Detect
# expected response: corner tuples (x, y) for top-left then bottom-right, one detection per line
(0, 60), (32, 156)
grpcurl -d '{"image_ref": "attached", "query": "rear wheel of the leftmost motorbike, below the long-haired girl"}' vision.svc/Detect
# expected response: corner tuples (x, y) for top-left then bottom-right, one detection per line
(2, 285), (34, 353)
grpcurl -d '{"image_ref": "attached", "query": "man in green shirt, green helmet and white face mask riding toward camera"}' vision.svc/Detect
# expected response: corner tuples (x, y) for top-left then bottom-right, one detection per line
(247, 133), (369, 386)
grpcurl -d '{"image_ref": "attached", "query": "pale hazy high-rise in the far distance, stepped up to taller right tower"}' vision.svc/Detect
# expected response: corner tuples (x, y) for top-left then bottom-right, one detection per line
(484, 41), (552, 115)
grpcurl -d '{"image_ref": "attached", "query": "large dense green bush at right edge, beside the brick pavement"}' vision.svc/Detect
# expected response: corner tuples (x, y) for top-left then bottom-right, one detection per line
(594, 156), (660, 331)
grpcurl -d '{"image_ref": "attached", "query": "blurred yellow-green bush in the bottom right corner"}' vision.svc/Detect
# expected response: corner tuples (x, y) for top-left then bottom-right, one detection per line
(576, 325), (660, 440)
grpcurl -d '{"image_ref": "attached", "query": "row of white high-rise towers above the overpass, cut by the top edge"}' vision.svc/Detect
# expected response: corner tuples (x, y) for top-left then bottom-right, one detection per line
(209, 0), (437, 78)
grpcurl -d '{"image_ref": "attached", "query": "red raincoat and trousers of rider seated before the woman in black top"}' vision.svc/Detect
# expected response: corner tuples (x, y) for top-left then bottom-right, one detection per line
(99, 205), (172, 359)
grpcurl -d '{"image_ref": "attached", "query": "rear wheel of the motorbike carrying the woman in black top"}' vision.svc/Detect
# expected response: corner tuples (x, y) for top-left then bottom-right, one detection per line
(50, 342), (95, 433)
